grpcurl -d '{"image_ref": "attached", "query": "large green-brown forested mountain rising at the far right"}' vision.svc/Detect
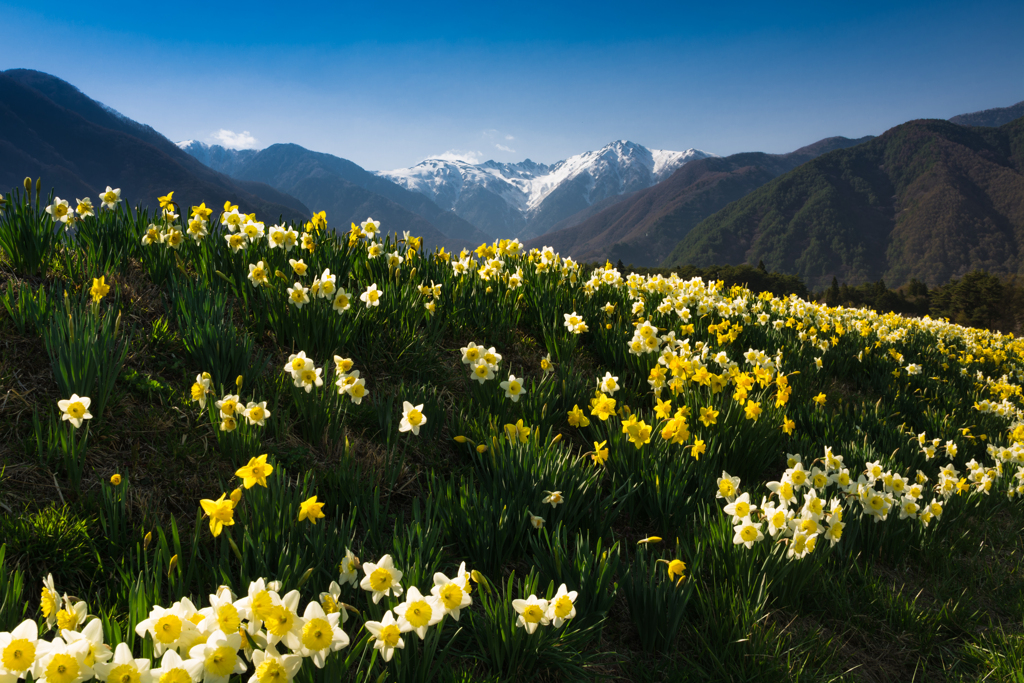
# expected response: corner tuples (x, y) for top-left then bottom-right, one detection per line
(665, 119), (1024, 288)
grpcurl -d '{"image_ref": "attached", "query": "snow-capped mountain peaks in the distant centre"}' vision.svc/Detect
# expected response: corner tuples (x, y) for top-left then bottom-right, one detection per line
(379, 140), (715, 238)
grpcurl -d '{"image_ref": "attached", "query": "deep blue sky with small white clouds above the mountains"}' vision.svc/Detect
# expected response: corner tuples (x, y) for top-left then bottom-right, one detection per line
(0, 0), (1024, 170)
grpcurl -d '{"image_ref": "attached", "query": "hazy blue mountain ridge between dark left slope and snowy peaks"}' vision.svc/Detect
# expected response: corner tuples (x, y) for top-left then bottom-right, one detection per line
(178, 140), (489, 247)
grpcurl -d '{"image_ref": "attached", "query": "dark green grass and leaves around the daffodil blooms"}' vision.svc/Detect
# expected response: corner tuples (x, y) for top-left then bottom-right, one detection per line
(0, 184), (1024, 683)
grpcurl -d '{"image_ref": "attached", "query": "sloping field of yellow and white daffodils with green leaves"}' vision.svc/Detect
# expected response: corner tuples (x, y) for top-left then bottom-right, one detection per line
(0, 179), (1024, 683)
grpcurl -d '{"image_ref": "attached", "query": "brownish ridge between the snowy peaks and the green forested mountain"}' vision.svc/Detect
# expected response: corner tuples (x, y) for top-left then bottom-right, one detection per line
(526, 137), (870, 266)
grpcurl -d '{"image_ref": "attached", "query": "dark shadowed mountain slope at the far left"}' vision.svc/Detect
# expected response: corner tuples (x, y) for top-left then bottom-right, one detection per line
(0, 69), (309, 221)
